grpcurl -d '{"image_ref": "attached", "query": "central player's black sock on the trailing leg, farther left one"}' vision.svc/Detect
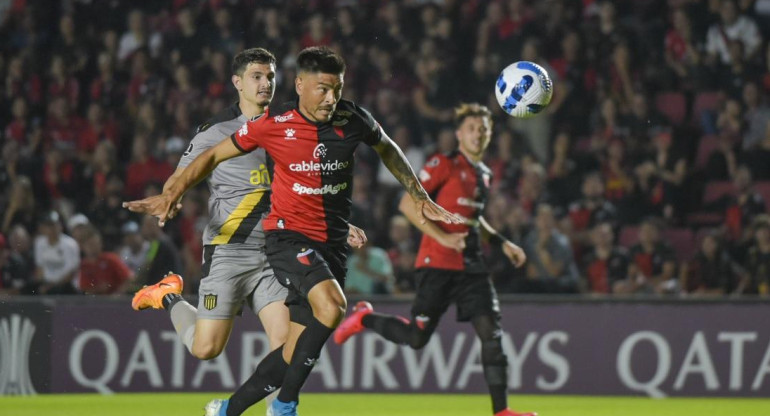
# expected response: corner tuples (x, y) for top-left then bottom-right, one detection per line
(227, 346), (289, 416)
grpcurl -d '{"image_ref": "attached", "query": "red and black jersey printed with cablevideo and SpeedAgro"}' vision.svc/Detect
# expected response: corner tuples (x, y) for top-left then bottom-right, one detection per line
(231, 100), (382, 244)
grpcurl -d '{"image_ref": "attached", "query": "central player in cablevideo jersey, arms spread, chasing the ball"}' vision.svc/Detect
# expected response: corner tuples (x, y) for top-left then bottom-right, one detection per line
(121, 47), (462, 416)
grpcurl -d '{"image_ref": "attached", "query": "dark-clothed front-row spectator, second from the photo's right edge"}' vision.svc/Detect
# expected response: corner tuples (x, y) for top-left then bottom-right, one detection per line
(680, 233), (748, 296)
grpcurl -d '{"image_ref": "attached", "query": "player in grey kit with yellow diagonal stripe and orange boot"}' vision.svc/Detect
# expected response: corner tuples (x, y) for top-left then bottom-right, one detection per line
(126, 48), (366, 412)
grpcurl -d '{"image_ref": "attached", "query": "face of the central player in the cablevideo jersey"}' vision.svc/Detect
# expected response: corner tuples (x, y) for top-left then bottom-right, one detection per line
(294, 72), (343, 122)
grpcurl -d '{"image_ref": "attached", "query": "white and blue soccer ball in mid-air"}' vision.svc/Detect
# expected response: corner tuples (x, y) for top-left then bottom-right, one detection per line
(495, 61), (553, 118)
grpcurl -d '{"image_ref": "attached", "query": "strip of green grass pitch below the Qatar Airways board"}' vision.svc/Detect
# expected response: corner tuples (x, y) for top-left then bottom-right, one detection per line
(0, 393), (770, 416)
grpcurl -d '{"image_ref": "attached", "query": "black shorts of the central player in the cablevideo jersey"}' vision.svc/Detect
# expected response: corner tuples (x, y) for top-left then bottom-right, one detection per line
(265, 230), (347, 326)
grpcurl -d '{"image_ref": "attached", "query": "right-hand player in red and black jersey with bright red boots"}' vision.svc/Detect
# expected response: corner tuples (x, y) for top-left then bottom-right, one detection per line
(334, 104), (536, 416)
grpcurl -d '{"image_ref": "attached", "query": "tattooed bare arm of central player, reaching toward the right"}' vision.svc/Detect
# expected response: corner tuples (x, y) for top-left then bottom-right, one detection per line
(373, 132), (463, 224)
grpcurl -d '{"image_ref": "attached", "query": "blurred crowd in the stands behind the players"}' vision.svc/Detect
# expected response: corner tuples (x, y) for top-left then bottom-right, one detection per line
(0, 0), (770, 296)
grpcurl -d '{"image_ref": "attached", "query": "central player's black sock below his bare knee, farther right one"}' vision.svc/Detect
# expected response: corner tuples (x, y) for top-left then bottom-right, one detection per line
(278, 318), (334, 402)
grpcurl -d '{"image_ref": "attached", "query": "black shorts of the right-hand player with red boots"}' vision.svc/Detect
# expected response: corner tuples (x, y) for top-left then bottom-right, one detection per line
(412, 268), (500, 323)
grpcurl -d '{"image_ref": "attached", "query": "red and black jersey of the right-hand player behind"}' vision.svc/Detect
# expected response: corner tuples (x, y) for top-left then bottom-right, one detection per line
(415, 151), (492, 273)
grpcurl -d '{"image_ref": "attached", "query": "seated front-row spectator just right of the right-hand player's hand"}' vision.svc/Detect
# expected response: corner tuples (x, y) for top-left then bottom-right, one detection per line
(517, 204), (578, 293)
